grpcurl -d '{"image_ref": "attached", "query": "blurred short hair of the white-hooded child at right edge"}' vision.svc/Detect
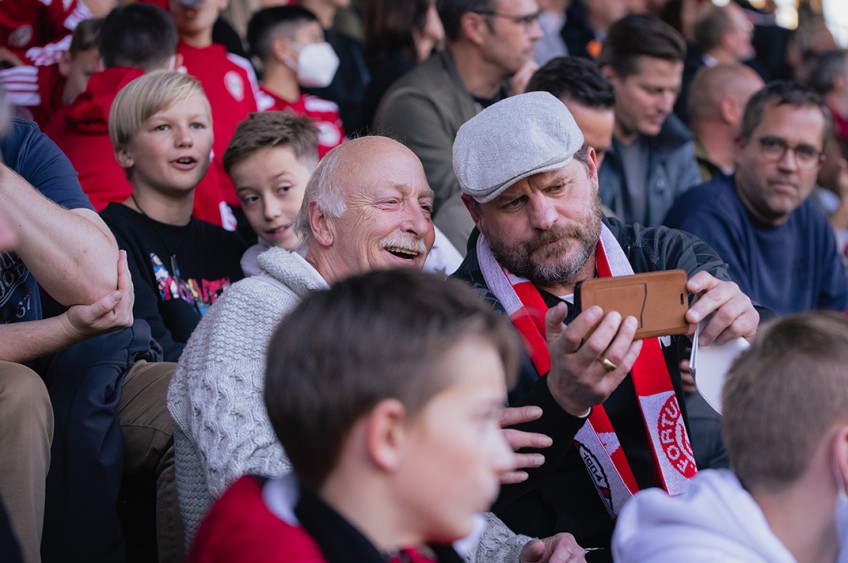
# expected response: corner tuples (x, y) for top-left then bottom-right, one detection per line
(722, 312), (848, 490)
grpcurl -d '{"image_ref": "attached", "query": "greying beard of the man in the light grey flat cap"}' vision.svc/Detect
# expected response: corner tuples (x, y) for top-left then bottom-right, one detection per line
(486, 199), (601, 286)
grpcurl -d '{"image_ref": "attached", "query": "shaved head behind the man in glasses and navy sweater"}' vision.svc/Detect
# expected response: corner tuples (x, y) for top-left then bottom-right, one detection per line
(689, 64), (763, 127)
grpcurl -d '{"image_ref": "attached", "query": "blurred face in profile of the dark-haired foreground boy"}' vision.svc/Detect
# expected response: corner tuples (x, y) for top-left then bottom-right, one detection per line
(397, 337), (515, 542)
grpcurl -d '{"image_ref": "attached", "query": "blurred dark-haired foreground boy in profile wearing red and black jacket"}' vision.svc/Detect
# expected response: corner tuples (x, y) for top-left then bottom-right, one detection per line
(189, 270), (518, 563)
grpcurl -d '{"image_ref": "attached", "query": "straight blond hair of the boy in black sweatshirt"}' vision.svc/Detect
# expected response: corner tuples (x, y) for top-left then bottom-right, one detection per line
(109, 70), (211, 150)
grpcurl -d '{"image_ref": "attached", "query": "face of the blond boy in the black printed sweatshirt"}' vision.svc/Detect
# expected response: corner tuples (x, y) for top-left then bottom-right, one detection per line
(119, 94), (212, 199)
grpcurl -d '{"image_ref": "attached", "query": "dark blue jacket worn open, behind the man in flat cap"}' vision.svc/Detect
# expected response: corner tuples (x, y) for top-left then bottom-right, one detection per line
(599, 114), (701, 227)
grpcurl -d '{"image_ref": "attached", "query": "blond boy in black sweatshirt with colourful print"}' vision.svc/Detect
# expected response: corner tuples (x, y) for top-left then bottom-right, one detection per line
(101, 71), (246, 361)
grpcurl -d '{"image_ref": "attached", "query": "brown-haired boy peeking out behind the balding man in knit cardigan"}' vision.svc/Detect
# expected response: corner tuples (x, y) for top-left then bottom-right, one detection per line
(224, 111), (318, 276)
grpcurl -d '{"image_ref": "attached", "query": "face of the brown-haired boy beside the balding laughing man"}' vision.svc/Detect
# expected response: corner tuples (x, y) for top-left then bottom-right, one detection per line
(230, 147), (310, 250)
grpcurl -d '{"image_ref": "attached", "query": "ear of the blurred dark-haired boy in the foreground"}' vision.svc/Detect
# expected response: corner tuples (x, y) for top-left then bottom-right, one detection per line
(364, 399), (407, 473)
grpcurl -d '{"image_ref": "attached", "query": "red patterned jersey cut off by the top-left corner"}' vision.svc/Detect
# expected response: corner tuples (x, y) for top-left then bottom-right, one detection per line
(0, 0), (91, 64)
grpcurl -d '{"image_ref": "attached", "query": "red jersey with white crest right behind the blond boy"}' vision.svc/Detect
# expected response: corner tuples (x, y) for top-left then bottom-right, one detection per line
(177, 41), (257, 207)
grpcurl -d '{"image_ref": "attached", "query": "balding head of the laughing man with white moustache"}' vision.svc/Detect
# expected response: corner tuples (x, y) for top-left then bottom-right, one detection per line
(296, 136), (435, 281)
